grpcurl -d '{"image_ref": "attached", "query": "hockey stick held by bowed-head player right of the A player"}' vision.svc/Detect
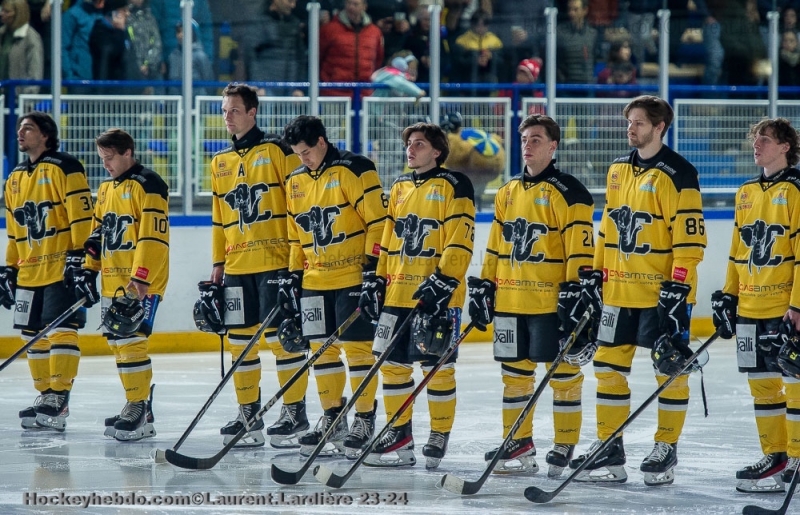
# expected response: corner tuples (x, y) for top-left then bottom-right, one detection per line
(164, 309), (361, 470)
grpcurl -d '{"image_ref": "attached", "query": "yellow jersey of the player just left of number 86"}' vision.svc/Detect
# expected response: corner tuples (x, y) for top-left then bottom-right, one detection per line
(481, 161), (594, 315)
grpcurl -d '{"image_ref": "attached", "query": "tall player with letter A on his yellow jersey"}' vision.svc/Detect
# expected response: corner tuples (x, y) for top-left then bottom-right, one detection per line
(211, 83), (308, 448)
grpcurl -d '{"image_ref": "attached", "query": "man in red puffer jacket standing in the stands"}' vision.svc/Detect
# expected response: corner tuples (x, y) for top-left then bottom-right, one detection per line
(319, 0), (384, 96)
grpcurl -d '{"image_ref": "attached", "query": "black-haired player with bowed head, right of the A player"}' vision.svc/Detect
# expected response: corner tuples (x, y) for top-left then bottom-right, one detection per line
(278, 116), (387, 458)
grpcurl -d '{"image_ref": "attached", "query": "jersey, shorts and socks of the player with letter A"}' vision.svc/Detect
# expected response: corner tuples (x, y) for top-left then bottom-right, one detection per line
(211, 127), (308, 404)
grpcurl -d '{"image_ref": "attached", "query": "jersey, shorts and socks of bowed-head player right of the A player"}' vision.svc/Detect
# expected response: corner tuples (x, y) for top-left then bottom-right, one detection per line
(286, 145), (386, 413)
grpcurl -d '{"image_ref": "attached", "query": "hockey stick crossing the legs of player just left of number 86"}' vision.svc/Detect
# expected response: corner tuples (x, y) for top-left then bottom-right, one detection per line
(436, 306), (594, 495)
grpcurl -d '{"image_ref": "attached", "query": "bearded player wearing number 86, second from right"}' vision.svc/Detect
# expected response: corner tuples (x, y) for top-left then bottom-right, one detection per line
(570, 95), (706, 486)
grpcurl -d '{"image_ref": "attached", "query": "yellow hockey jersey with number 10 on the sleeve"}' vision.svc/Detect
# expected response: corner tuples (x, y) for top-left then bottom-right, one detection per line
(85, 163), (169, 297)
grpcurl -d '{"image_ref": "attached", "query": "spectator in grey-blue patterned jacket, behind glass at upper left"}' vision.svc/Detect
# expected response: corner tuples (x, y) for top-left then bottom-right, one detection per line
(128, 0), (163, 92)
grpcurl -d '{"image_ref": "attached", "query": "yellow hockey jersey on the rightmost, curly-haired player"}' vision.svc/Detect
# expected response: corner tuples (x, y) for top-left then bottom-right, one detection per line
(723, 168), (800, 318)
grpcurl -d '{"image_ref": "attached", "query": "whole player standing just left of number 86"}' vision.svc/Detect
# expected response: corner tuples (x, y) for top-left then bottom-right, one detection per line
(468, 114), (599, 477)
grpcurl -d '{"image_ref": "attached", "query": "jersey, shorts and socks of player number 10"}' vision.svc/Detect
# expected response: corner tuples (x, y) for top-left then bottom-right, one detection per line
(84, 163), (169, 402)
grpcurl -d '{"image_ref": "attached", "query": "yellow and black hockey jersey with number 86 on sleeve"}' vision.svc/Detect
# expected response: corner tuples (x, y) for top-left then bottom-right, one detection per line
(593, 146), (706, 308)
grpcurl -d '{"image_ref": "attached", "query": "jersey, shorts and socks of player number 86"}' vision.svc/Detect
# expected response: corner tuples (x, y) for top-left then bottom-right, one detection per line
(593, 146), (706, 444)
